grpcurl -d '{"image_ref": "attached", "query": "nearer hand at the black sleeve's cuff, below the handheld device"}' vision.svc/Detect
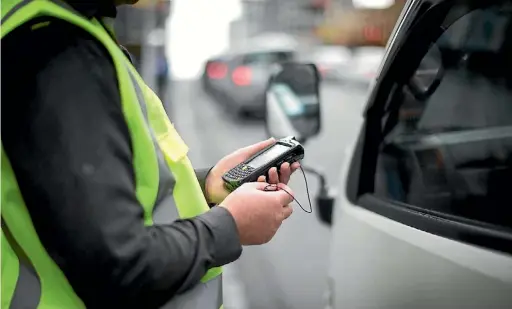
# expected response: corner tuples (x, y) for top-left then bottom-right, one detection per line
(219, 182), (293, 246)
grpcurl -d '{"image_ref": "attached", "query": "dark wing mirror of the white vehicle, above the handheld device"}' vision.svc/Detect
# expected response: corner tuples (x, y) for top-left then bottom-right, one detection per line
(265, 62), (321, 143)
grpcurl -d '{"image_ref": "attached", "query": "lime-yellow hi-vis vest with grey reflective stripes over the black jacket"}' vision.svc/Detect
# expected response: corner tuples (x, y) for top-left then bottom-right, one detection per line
(1, 0), (222, 309)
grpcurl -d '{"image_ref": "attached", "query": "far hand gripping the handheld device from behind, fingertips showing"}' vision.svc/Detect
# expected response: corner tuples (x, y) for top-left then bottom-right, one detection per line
(206, 138), (300, 204)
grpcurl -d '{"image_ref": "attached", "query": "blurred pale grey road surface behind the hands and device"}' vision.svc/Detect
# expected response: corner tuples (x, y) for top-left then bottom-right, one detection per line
(166, 81), (367, 309)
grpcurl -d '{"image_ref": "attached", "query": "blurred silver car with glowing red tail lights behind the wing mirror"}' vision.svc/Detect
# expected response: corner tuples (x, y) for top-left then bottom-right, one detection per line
(202, 39), (297, 117)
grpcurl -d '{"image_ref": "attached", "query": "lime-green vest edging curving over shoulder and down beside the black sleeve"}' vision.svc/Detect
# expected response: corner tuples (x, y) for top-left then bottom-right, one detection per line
(0, 0), (163, 219)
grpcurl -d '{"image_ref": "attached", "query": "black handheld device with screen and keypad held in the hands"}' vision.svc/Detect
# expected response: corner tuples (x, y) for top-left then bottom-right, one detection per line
(222, 137), (304, 191)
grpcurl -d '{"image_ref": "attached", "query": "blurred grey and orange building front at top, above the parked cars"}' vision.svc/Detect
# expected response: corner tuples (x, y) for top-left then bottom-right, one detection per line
(232, 0), (406, 47)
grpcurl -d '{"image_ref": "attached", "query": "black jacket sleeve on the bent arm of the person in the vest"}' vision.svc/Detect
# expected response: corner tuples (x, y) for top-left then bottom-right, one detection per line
(2, 22), (242, 309)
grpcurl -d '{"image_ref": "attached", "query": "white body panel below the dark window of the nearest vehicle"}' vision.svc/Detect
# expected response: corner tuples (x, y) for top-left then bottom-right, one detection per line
(326, 137), (512, 309)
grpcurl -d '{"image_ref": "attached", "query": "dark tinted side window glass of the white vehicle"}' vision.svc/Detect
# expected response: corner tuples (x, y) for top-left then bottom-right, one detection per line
(374, 5), (512, 227)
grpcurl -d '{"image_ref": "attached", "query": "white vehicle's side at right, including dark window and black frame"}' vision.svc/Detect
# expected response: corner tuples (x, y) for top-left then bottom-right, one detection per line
(326, 1), (512, 309)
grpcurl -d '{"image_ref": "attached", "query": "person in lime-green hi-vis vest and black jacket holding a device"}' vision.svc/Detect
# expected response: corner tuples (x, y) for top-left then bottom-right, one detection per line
(1, 0), (298, 309)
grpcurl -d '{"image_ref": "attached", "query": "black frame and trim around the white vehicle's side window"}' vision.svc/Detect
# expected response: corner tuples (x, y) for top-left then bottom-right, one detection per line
(345, 0), (512, 254)
